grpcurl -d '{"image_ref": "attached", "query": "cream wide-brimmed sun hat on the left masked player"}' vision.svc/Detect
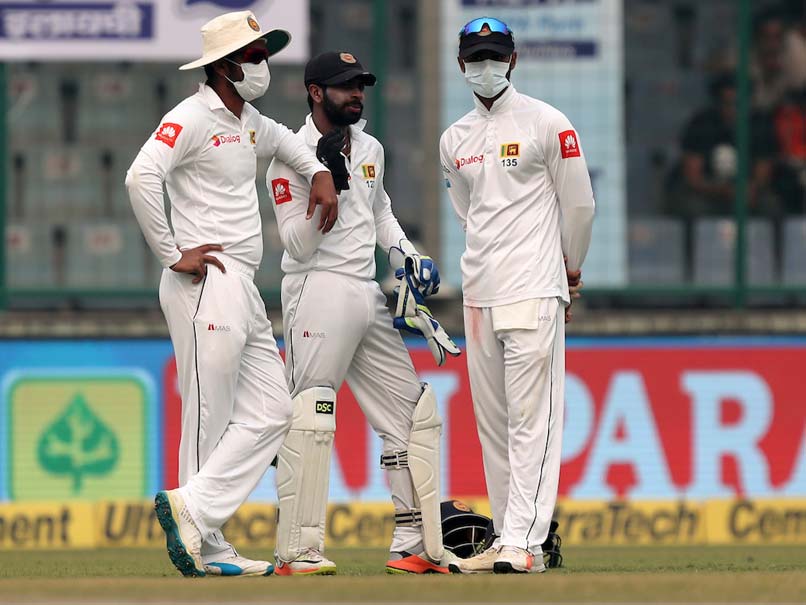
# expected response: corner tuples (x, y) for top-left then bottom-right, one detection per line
(179, 11), (291, 69)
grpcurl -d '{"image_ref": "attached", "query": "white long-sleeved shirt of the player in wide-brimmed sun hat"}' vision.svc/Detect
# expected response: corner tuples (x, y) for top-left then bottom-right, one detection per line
(126, 84), (327, 269)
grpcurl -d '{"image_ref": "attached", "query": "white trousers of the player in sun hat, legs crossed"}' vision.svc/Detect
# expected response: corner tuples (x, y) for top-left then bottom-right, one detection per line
(160, 254), (292, 562)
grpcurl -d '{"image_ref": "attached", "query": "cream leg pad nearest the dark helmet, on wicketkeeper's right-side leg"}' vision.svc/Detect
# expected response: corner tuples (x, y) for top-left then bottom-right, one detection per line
(408, 384), (443, 561)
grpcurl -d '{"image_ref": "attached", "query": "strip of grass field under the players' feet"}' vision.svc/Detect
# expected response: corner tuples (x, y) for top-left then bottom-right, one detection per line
(0, 546), (806, 605)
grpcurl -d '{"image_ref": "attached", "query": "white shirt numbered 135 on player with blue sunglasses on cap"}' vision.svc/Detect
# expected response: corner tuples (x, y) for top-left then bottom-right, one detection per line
(439, 85), (594, 307)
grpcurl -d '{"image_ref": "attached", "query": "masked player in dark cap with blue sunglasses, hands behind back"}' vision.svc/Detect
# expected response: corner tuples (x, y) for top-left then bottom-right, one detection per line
(440, 17), (594, 573)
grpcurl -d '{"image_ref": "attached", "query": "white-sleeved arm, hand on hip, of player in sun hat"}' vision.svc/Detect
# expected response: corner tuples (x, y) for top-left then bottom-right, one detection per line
(126, 112), (198, 267)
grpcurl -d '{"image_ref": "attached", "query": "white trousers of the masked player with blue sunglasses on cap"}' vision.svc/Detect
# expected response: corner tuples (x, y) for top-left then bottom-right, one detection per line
(464, 298), (565, 553)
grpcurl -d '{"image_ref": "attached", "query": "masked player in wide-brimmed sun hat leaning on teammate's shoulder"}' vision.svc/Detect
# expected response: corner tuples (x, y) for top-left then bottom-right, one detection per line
(126, 11), (338, 576)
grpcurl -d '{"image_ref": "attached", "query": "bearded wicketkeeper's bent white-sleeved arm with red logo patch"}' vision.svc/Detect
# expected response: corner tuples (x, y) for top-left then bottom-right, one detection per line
(266, 158), (325, 263)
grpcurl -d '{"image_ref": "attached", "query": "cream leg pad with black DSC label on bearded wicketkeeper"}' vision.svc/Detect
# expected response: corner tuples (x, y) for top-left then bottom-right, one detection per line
(277, 387), (336, 561)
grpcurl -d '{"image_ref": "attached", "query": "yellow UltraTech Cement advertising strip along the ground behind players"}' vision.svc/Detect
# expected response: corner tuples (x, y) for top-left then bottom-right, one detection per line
(0, 499), (806, 550)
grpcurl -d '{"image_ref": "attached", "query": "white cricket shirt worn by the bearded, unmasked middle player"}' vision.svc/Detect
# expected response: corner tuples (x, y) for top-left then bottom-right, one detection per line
(266, 114), (414, 279)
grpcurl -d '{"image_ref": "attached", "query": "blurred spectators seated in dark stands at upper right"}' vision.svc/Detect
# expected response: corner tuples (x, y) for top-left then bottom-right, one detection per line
(666, 0), (806, 223)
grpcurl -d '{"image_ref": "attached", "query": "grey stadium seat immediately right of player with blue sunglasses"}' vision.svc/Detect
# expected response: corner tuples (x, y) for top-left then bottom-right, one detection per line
(629, 218), (685, 284)
